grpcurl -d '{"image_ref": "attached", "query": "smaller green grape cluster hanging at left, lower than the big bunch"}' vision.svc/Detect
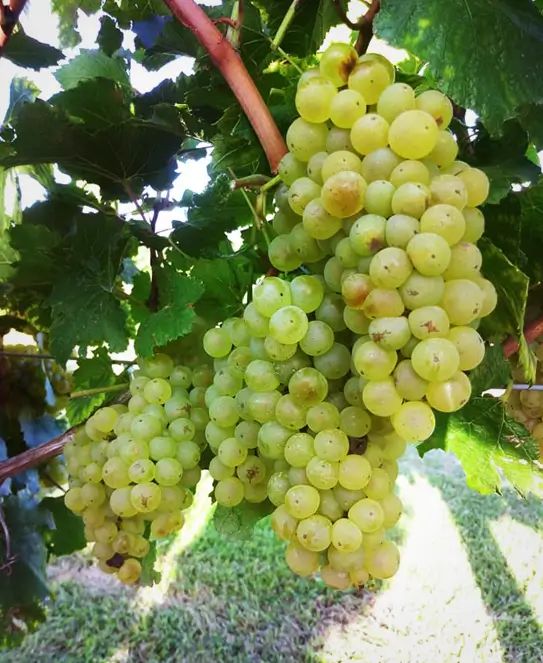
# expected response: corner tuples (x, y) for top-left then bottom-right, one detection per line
(64, 354), (212, 584)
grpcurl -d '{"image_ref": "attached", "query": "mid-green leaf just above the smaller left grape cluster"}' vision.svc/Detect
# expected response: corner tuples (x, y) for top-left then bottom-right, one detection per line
(134, 265), (204, 357)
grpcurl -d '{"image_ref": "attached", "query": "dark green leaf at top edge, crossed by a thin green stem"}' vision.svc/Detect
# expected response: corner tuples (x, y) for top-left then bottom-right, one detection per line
(254, 0), (341, 57)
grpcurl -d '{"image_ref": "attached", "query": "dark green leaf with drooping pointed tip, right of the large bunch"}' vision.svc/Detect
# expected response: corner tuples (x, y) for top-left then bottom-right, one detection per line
(478, 238), (536, 382)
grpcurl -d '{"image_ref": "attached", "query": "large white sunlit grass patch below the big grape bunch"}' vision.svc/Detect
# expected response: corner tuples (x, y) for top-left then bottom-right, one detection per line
(322, 473), (503, 663)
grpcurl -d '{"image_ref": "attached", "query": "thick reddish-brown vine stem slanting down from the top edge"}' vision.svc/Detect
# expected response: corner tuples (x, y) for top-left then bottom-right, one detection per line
(164, 0), (287, 173)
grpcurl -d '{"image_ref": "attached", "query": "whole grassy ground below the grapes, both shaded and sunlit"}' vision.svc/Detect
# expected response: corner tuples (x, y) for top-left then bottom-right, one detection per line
(0, 450), (543, 663)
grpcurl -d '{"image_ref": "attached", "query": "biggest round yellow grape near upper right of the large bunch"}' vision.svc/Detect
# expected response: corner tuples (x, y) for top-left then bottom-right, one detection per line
(388, 110), (439, 159)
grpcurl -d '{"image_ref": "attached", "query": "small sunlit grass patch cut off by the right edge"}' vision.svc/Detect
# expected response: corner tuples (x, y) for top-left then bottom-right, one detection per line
(490, 515), (543, 626)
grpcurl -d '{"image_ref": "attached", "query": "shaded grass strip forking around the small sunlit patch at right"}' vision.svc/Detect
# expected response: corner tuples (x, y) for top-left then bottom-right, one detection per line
(404, 453), (543, 663)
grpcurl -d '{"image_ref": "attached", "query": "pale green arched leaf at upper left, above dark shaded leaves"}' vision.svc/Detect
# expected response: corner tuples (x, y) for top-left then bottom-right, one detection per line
(55, 51), (131, 90)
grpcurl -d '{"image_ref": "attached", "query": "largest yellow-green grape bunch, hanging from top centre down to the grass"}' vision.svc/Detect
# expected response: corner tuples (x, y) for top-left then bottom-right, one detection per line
(204, 44), (497, 589)
